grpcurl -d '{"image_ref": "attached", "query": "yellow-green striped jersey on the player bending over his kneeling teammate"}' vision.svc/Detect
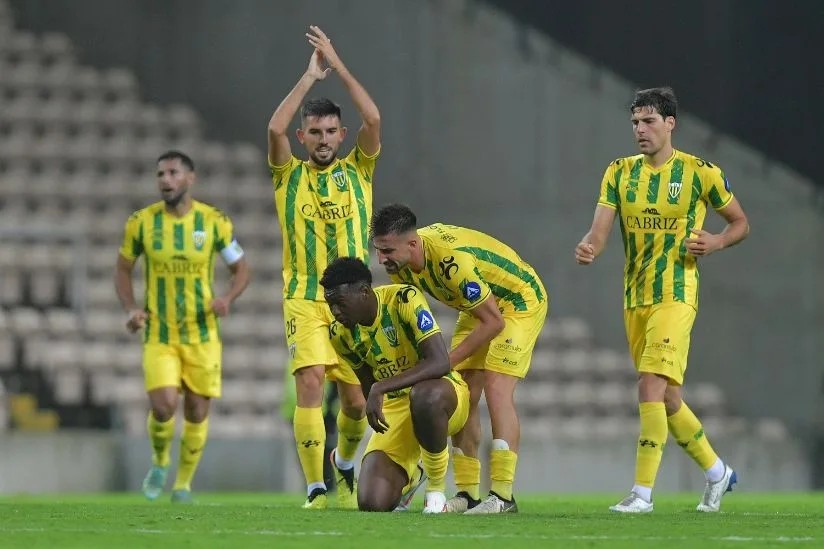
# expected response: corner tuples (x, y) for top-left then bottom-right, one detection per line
(391, 223), (547, 314)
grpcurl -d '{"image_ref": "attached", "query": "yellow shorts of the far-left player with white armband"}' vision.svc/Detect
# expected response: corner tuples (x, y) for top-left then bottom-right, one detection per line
(143, 341), (223, 398)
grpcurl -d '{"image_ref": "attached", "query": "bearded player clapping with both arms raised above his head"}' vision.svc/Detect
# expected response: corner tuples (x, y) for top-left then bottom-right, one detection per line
(269, 26), (380, 509)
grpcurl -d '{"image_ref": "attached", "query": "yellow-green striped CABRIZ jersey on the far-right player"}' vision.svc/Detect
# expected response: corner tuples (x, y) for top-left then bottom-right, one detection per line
(598, 151), (733, 309)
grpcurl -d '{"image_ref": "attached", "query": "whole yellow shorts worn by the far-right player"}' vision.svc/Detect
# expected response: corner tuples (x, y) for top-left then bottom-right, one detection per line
(624, 301), (695, 385)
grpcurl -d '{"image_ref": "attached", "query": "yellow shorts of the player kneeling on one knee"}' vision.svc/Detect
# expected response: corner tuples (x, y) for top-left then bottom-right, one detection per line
(363, 372), (469, 479)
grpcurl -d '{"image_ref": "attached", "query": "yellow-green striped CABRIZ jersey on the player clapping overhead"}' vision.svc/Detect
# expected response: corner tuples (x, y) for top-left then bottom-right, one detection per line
(269, 145), (380, 301)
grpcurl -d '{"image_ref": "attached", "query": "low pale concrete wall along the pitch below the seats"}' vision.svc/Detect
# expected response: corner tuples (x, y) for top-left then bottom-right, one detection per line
(0, 431), (811, 497)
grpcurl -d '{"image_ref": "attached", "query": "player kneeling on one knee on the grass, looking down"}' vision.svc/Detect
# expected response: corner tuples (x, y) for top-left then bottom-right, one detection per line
(320, 257), (469, 513)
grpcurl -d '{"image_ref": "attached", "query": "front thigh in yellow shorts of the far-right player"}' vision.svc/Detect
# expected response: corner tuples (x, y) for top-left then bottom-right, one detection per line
(638, 302), (695, 385)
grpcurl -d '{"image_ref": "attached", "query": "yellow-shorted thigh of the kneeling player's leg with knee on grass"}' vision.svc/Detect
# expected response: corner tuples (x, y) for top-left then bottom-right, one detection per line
(363, 396), (421, 479)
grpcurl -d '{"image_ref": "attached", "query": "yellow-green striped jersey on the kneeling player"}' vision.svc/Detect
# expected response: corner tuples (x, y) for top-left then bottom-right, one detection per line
(329, 284), (441, 398)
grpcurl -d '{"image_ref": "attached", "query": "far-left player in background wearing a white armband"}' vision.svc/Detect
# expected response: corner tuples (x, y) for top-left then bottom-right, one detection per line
(115, 151), (249, 503)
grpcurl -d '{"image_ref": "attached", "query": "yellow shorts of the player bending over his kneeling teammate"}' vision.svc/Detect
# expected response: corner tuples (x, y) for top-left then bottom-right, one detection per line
(451, 300), (549, 379)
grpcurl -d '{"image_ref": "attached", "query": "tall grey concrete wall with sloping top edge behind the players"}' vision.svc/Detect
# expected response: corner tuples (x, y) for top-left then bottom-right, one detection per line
(12, 0), (824, 437)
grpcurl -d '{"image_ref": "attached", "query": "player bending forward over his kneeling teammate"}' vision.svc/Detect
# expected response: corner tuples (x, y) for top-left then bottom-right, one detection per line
(372, 205), (548, 514)
